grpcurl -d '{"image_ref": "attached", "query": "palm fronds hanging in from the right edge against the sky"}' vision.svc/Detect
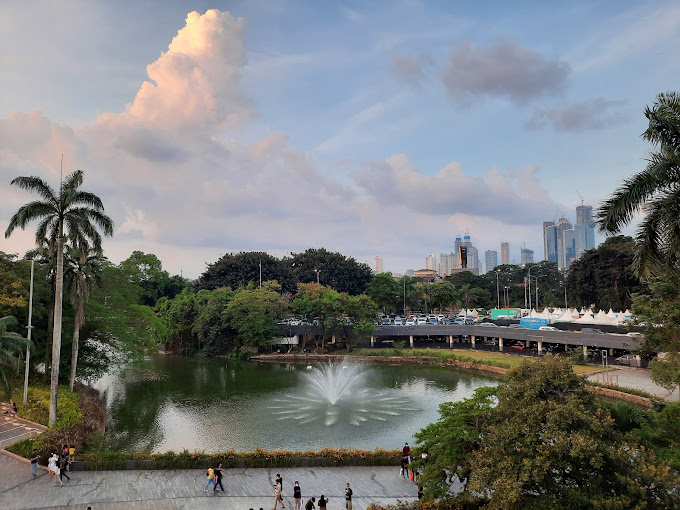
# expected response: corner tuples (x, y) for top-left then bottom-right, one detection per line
(597, 92), (680, 276)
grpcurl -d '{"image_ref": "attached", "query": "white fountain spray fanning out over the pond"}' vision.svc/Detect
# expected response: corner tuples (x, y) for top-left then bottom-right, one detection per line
(270, 359), (417, 427)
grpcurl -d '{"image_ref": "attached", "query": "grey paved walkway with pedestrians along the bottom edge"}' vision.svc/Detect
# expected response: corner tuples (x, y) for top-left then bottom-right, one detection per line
(0, 452), (417, 510)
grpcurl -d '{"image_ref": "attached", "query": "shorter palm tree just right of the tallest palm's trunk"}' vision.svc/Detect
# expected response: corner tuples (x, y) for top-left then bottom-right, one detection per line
(64, 246), (106, 391)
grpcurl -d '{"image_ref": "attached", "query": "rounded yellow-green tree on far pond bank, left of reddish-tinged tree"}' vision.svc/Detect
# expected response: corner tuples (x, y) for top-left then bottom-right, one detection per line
(224, 282), (286, 348)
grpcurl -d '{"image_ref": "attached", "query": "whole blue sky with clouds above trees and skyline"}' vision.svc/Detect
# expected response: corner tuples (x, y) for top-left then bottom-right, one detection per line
(0, 0), (680, 278)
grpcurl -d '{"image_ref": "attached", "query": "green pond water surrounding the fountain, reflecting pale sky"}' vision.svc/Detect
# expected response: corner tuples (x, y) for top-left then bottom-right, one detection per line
(95, 356), (498, 452)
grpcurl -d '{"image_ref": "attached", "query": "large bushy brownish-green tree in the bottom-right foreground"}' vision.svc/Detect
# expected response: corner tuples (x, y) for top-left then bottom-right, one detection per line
(468, 355), (680, 510)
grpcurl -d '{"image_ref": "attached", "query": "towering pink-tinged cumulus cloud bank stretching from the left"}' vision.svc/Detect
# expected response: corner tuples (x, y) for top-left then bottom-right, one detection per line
(0, 10), (564, 276)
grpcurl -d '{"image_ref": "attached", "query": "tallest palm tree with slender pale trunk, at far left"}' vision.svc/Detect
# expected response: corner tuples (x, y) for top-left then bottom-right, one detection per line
(5, 170), (113, 425)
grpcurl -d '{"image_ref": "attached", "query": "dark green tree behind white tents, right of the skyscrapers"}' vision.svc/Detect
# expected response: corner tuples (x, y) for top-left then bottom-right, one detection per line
(565, 236), (644, 310)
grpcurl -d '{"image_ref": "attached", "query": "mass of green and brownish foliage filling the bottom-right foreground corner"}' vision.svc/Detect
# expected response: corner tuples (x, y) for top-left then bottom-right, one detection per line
(417, 356), (680, 509)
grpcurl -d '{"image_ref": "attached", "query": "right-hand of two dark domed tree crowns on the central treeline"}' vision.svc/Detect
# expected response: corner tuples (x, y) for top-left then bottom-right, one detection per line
(283, 248), (373, 296)
